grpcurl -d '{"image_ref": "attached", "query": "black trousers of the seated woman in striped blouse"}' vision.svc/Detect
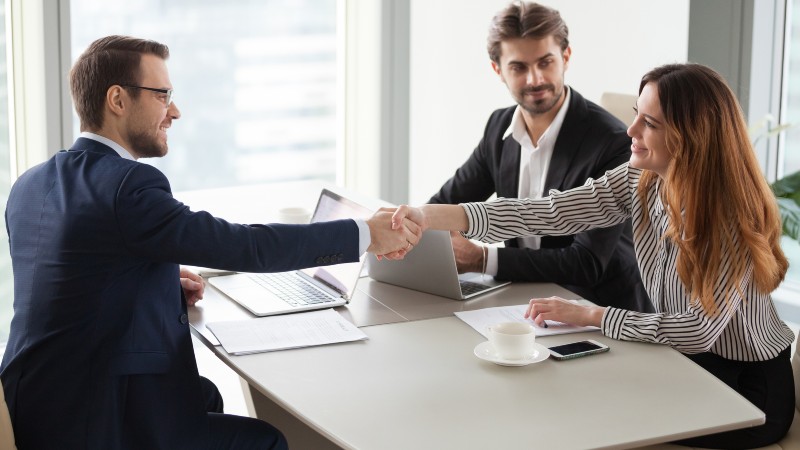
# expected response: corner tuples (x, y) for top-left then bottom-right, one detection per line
(675, 347), (795, 449)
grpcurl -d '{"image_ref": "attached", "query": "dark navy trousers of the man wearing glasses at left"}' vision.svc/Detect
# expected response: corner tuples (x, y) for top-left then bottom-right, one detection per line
(200, 377), (289, 450)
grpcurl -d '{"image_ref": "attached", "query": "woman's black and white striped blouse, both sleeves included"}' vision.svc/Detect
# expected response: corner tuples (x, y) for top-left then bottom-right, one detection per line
(462, 164), (794, 361)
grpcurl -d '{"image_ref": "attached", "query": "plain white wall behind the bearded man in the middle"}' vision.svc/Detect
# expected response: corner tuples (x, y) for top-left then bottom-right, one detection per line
(409, 0), (689, 204)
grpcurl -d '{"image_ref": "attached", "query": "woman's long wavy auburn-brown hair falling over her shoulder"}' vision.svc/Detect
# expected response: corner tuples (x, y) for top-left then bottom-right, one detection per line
(638, 64), (789, 315)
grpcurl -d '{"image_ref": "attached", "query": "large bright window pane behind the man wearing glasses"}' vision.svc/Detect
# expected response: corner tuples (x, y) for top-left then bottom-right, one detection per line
(65, 0), (337, 191)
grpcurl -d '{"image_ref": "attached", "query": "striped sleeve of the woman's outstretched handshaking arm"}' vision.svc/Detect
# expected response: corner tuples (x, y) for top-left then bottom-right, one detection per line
(462, 163), (639, 242)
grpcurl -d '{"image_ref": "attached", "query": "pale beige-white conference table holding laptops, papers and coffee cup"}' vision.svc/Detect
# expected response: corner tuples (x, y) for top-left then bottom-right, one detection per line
(190, 279), (764, 450)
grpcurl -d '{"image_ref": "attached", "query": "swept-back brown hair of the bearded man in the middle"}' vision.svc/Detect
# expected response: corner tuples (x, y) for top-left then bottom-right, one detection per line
(486, 1), (569, 64)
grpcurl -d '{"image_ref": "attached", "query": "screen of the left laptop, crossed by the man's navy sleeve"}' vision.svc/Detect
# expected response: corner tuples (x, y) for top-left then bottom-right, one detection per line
(301, 189), (373, 299)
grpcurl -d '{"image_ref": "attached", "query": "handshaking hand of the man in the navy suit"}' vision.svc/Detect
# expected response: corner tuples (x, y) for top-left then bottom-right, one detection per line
(367, 212), (422, 259)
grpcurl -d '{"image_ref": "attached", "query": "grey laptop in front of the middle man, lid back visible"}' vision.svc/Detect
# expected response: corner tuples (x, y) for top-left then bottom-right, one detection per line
(367, 230), (509, 300)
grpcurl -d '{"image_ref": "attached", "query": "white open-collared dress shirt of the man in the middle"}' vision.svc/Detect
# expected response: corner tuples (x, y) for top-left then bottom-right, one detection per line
(486, 86), (571, 276)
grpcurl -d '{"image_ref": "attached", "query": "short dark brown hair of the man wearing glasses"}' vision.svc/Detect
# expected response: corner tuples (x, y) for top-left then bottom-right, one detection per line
(69, 36), (169, 131)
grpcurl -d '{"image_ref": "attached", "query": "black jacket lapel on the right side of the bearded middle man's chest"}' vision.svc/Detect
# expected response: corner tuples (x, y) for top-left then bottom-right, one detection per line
(544, 88), (589, 191)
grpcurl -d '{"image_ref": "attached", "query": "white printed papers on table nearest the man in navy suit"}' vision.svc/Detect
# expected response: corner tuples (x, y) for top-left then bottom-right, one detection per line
(207, 309), (368, 355)
